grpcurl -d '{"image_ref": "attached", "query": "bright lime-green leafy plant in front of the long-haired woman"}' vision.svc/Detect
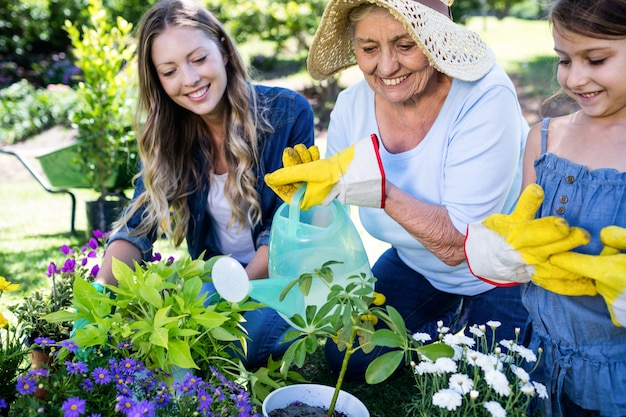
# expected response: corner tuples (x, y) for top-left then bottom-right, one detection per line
(46, 250), (297, 402)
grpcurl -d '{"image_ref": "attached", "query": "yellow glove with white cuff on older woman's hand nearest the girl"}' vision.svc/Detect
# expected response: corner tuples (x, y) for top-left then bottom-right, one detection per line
(465, 184), (589, 292)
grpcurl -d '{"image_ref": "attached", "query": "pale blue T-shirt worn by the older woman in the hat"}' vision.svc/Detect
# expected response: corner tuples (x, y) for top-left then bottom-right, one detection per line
(327, 66), (528, 295)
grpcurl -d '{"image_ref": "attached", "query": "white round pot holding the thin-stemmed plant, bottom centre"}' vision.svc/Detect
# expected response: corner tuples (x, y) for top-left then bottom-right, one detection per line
(262, 384), (370, 417)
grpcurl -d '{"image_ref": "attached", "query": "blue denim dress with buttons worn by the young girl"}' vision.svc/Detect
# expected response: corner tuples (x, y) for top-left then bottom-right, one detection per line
(522, 119), (626, 417)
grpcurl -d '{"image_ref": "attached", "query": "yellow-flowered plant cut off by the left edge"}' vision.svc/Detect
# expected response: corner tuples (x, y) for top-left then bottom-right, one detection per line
(0, 276), (27, 416)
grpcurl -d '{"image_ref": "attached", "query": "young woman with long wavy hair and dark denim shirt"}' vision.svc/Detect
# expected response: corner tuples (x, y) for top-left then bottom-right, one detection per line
(92, 0), (314, 367)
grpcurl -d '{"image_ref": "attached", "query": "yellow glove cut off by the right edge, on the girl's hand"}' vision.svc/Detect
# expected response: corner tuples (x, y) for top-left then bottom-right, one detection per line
(550, 226), (626, 327)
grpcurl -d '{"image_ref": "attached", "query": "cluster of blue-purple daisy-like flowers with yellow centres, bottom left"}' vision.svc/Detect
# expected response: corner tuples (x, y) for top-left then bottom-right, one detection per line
(16, 339), (259, 417)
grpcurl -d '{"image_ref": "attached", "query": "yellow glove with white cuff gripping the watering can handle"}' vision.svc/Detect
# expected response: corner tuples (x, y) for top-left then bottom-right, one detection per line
(265, 135), (385, 210)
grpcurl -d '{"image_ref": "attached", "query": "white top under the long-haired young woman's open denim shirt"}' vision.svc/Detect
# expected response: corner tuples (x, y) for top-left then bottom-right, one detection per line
(207, 174), (255, 265)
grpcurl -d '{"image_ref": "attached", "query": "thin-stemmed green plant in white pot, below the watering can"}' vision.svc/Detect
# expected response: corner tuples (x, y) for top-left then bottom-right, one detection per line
(263, 261), (453, 417)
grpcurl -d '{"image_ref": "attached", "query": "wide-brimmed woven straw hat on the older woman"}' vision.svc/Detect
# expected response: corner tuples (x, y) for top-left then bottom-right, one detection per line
(307, 0), (495, 81)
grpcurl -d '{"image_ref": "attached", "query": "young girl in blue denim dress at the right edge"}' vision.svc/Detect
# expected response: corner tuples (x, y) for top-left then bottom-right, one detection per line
(523, 0), (626, 417)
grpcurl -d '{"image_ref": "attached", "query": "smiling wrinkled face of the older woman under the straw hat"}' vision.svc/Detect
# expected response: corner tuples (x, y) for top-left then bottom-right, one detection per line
(354, 10), (436, 103)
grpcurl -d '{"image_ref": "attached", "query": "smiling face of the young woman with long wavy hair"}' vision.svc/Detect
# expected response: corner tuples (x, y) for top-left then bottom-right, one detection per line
(151, 27), (228, 118)
